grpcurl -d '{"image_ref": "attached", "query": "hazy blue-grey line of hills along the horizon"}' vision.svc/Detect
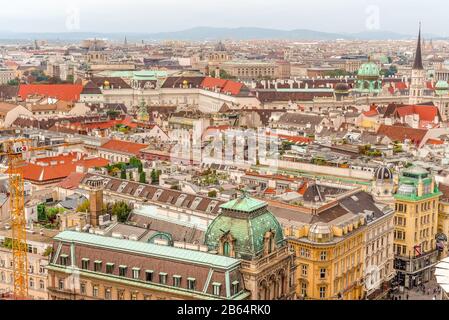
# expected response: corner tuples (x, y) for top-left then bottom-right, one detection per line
(0, 27), (447, 42)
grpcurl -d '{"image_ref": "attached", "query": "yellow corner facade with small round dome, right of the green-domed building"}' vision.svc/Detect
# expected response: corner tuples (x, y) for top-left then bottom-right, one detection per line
(287, 222), (365, 300)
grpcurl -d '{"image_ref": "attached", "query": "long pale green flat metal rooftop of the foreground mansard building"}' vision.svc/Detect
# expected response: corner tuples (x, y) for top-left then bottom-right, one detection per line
(54, 231), (240, 269)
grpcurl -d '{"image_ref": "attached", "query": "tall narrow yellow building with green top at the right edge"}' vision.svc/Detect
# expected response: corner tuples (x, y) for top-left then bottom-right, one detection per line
(393, 167), (441, 289)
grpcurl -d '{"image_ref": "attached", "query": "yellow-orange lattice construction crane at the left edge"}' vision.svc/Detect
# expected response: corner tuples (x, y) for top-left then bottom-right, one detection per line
(0, 138), (74, 299)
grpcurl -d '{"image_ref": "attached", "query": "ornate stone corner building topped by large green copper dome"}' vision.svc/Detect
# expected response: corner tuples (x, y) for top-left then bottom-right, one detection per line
(205, 195), (295, 300)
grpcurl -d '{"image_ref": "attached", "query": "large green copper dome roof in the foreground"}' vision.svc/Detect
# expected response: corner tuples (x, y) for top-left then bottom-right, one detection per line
(205, 195), (284, 260)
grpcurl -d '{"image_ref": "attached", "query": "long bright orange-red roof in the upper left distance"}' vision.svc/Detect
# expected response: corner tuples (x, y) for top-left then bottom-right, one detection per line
(18, 84), (83, 101)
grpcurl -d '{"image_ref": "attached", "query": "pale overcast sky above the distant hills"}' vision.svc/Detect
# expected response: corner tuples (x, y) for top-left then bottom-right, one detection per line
(0, 0), (449, 36)
